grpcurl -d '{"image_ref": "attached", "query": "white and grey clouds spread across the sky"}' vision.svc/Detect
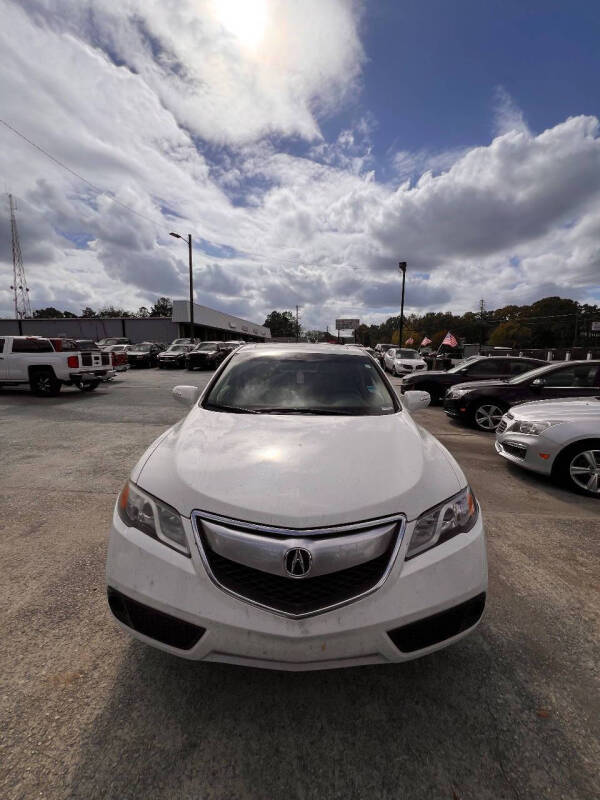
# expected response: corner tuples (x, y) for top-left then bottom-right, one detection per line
(0, 0), (600, 327)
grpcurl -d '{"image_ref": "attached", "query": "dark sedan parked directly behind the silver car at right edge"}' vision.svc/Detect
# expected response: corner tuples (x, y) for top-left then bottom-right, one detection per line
(444, 360), (600, 431)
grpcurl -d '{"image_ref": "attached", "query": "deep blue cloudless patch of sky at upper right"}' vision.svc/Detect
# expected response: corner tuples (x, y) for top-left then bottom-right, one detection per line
(362, 0), (600, 154)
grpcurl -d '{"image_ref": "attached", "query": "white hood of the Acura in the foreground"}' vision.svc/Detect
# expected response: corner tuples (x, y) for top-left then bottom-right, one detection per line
(132, 407), (466, 528)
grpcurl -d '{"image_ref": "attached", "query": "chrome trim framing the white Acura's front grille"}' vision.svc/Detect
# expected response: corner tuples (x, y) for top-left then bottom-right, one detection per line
(191, 511), (406, 619)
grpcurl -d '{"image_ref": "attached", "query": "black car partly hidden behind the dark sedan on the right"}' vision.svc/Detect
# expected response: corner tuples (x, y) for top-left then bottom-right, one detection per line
(402, 356), (546, 403)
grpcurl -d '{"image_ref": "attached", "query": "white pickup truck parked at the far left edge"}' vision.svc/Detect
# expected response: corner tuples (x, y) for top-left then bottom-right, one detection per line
(0, 336), (115, 397)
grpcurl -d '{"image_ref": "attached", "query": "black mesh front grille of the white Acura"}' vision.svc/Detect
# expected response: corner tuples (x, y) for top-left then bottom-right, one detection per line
(193, 512), (404, 617)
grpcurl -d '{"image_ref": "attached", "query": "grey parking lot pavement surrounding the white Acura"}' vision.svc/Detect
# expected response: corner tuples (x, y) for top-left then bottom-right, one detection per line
(0, 370), (600, 800)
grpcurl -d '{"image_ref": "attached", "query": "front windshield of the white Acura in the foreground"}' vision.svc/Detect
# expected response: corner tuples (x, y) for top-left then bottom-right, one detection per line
(204, 351), (397, 415)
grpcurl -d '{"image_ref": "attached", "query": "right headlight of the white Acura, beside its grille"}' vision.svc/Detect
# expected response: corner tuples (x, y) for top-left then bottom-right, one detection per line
(406, 486), (479, 558)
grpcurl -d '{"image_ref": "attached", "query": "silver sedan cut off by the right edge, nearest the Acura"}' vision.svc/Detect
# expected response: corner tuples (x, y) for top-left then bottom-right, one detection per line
(496, 397), (600, 498)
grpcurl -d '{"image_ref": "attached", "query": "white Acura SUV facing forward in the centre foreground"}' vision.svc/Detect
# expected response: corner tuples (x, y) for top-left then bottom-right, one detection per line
(107, 344), (487, 670)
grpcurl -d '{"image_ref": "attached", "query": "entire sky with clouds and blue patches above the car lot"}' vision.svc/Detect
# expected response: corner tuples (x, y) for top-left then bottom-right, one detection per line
(0, 0), (600, 328)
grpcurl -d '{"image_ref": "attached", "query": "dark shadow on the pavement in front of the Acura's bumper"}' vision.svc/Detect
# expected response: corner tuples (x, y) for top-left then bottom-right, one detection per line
(69, 623), (594, 800)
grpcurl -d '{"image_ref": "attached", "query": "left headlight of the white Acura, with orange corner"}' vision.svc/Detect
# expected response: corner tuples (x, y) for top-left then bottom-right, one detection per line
(117, 481), (190, 556)
